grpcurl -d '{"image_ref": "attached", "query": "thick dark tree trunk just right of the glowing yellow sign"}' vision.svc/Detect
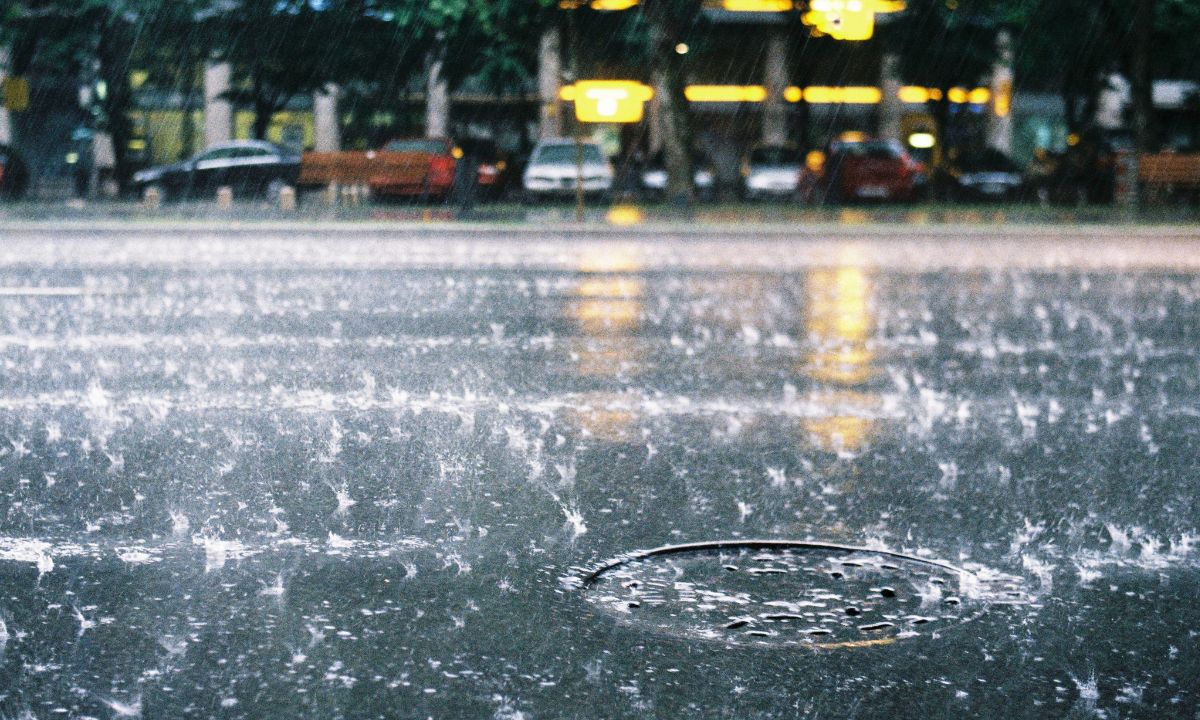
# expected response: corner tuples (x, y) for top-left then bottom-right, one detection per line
(643, 0), (695, 206)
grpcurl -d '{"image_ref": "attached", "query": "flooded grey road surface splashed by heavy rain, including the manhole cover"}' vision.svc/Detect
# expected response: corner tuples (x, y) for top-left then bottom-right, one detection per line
(0, 230), (1200, 719)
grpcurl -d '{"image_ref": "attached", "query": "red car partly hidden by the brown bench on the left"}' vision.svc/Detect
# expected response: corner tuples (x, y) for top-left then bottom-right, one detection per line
(368, 138), (463, 200)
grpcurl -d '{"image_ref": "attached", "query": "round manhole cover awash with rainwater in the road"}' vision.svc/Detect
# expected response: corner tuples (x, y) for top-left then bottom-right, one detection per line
(576, 540), (1025, 648)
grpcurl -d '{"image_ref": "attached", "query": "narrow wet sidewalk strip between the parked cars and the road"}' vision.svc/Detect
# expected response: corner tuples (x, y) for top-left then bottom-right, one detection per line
(0, 200), (1200, 233)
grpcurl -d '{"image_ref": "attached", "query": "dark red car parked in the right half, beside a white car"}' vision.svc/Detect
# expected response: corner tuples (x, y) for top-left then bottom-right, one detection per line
(800, 139), (929, 203)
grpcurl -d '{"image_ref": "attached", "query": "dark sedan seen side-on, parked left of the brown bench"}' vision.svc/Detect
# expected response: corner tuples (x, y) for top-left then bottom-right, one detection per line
(133, 140), (300, 199)
